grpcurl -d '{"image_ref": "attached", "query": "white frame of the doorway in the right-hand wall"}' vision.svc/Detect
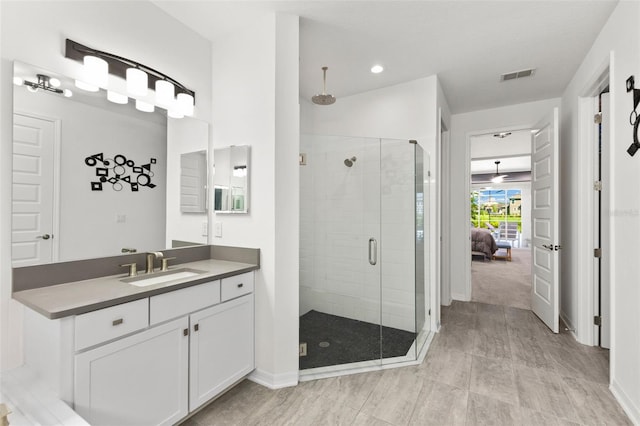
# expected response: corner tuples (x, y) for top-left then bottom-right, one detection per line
(576, 57), (614, 346)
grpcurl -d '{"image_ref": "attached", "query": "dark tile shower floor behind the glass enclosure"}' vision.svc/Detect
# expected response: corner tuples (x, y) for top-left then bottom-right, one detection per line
(300, 311), (415, 370)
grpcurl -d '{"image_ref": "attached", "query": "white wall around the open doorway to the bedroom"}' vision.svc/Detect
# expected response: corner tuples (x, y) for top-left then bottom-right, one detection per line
(443, 98), (560, 300)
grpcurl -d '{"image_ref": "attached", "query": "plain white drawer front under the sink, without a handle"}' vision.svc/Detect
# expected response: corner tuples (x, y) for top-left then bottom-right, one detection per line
(149, 280), (220, 325)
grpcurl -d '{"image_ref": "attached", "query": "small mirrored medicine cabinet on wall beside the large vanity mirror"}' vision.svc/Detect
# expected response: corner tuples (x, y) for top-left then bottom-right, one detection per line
(213, 145), (251, 213)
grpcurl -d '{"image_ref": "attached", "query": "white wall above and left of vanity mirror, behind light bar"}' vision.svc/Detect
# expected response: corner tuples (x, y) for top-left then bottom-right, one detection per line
(0, 1), (211, 370)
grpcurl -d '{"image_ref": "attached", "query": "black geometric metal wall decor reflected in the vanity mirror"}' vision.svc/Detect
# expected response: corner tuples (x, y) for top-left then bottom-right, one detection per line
(84, 152), (156, 192)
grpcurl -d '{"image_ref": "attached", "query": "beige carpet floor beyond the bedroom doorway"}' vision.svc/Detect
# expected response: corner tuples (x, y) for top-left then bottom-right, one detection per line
(471, 248), (531, 309)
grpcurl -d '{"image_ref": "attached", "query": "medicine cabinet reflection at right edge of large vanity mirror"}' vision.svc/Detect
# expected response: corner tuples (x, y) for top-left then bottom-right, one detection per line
(180, 150), (207, 213)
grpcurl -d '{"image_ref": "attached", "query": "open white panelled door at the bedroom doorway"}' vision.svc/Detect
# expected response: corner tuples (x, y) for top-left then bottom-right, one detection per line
(531, 108), (561, 333)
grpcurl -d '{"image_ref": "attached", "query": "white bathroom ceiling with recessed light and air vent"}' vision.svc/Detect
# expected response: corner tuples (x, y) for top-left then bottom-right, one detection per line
(153, 0), (617, 114)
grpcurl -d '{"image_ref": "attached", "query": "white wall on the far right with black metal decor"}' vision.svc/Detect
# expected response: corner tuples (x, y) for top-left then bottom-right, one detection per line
(560, 1), (640, 424)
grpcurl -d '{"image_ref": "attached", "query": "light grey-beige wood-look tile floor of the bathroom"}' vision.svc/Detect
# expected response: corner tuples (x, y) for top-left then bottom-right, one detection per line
(184, 302), (631, 426)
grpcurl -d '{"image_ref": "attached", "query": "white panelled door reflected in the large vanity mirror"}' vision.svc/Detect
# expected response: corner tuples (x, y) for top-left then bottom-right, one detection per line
(11, 114), (57, 266)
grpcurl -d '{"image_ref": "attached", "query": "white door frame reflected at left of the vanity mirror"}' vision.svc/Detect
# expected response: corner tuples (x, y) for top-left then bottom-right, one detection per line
(11, 110), (62, 262)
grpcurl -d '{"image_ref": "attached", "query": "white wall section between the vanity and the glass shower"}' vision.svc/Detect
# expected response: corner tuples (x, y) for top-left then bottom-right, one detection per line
(212, 14), (300, 387)
